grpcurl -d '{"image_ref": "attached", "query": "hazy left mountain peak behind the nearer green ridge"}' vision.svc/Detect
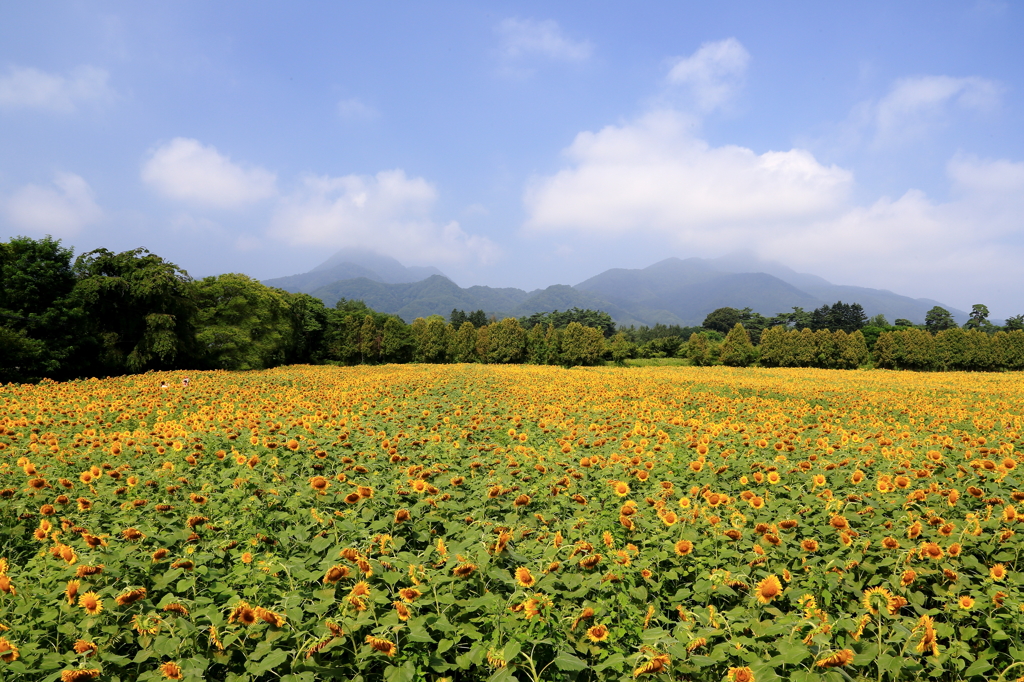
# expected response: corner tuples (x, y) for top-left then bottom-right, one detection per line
(263, 249), (444, 294)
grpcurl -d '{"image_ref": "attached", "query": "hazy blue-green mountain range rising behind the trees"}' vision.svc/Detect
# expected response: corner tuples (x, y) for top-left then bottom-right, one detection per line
(263, 249), (968, 327)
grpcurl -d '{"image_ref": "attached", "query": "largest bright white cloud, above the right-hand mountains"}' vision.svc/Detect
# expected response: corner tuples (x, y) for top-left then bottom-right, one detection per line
(524, 111), (852, 242)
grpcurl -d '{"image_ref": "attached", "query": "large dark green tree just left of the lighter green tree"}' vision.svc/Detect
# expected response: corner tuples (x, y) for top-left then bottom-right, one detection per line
(72, 249), (198, 374)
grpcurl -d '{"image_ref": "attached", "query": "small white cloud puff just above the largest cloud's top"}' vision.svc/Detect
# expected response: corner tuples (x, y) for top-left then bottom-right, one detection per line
(667, 38), (751, 112)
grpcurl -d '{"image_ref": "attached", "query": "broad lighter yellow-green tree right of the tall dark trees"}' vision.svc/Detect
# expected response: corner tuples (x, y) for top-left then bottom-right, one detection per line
(194, 273), (294, 370)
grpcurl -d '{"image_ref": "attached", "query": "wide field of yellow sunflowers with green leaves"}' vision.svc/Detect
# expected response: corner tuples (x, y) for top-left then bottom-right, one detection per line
(0, 365), (1024, 682)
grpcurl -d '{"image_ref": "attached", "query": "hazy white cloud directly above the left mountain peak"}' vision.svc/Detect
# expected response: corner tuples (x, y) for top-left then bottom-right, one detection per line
(270, 170), (497, 262)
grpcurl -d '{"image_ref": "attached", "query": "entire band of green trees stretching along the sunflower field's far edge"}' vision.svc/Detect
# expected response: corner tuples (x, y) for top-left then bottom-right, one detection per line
(0, 237), (1024, 383)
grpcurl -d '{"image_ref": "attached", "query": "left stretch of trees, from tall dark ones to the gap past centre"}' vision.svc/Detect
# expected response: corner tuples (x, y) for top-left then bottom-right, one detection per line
(0, 237), (610, 383)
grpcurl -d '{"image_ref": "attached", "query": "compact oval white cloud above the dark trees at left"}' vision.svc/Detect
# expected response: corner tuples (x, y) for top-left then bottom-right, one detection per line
(142, 137), (278, 208)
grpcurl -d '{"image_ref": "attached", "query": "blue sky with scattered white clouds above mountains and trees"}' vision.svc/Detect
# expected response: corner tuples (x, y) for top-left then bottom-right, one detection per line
(0, 1), (1024, 316)
